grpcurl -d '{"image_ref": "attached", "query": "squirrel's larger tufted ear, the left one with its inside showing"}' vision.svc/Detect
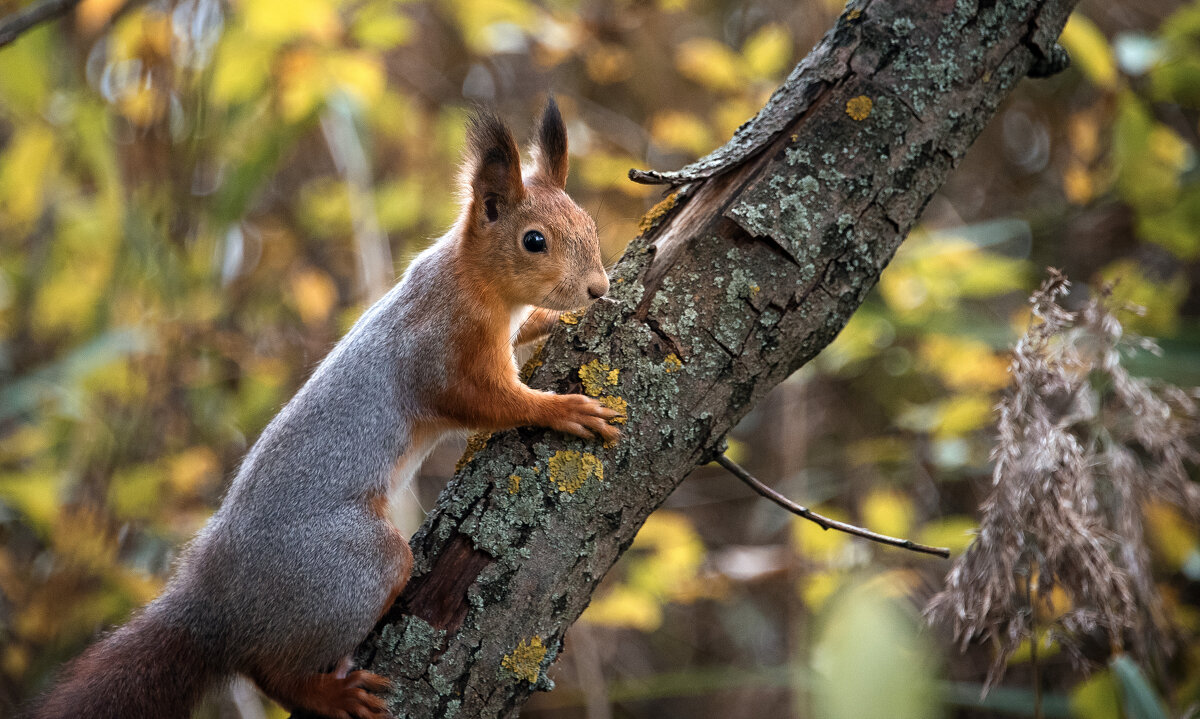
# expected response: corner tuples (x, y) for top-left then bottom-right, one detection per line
(464, 109), (524, 222)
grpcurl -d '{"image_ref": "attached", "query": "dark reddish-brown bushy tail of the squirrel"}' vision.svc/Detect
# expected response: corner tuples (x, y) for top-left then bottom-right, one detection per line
(30, 612), (223, 719)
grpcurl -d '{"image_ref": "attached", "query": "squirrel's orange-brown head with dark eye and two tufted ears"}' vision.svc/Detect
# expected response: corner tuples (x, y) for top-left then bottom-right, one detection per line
(461, 97), (608, 310)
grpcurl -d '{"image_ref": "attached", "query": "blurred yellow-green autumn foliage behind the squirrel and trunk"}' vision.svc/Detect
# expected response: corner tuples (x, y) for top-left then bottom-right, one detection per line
(0, 0), (1200, 719)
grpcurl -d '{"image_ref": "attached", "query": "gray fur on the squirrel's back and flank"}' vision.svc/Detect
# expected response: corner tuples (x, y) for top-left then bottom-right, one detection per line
(156, 232), (456, 673)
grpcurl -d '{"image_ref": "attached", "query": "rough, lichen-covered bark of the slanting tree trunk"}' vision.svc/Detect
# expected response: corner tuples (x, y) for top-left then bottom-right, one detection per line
(319, 0), (1074, 718)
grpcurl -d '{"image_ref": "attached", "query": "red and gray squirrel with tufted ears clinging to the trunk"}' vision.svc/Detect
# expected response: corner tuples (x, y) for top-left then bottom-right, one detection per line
(32, 97), (619, 719)
